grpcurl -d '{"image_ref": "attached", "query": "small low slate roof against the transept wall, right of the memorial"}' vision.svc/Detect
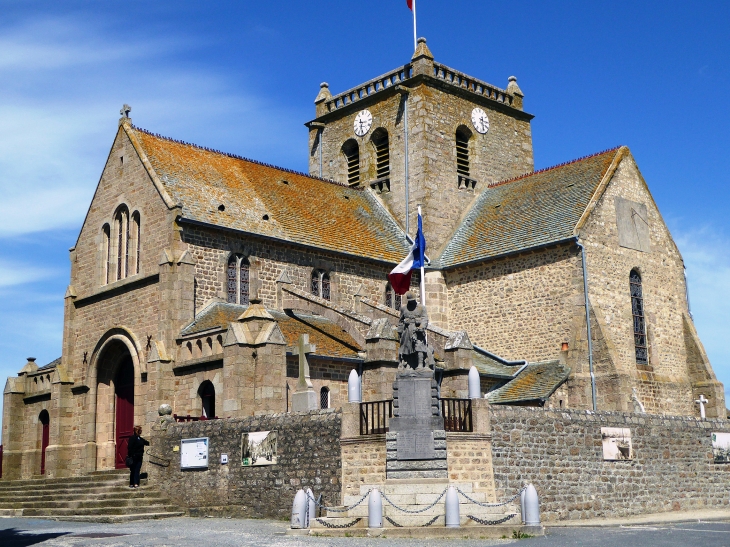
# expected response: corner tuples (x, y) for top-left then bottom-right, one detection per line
(487, 361), (570, 404)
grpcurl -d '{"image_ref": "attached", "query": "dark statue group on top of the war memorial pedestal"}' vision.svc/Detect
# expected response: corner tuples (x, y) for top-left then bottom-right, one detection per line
(398, 291), (435, 370)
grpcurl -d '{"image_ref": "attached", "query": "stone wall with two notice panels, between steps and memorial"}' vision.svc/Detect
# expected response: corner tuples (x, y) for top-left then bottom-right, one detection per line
(149, 409), (342, 519)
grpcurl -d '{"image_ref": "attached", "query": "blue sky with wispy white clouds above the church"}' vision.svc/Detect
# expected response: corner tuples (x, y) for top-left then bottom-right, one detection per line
(0, 0), (730, 422)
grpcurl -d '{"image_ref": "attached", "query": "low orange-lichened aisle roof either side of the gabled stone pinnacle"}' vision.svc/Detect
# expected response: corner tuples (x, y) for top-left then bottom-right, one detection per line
(180, 302), (362, 359)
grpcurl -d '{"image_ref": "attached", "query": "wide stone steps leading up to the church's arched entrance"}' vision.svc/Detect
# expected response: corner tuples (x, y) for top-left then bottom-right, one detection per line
(0, 469), (185, 522)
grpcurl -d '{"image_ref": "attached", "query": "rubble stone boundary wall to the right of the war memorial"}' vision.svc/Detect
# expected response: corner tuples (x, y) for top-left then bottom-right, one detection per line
(490, 407), (730, 521)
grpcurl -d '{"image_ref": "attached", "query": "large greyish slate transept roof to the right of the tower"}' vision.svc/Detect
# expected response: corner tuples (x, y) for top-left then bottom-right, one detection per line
(433, 148), (621, 268)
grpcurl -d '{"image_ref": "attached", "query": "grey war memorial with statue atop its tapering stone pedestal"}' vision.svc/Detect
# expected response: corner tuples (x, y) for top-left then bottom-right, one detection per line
(386, 294), (447, 479)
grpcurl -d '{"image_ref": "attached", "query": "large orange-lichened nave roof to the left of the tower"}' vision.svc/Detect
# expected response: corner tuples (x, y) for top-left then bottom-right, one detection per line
(124, 125), (410, 263)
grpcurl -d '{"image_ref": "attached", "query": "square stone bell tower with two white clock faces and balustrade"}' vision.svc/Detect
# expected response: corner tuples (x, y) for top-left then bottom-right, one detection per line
(306, 38), (534, 255)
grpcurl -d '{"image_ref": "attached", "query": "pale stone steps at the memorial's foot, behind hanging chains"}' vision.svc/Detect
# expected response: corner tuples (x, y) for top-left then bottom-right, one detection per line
(310, 479), (522, 537)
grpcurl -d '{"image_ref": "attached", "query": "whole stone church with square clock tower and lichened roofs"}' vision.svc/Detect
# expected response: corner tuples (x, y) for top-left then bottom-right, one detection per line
(2, 39), (725, 479)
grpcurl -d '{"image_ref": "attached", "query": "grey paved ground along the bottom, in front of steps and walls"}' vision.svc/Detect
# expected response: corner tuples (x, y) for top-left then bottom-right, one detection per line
(0, 518), (730, 547)
